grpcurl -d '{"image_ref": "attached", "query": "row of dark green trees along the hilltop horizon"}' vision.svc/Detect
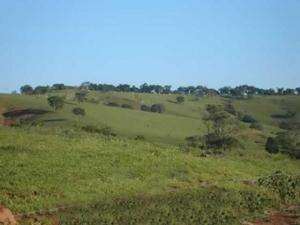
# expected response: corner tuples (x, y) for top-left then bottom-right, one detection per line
(20, 82), (300, 97)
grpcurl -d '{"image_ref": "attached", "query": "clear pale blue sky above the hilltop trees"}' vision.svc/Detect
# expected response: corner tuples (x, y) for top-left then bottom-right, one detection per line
(0, 0), (300, 92)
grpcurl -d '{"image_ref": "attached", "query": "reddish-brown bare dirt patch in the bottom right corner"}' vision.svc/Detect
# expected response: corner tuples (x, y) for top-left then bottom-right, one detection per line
(244, 205), (300, 225)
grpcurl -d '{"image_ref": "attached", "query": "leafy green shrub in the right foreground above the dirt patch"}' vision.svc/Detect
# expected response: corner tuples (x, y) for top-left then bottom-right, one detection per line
(258, 171), (297, 201)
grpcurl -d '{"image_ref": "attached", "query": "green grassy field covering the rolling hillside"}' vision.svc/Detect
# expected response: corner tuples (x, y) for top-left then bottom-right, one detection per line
(0, 91), (300, 224)
